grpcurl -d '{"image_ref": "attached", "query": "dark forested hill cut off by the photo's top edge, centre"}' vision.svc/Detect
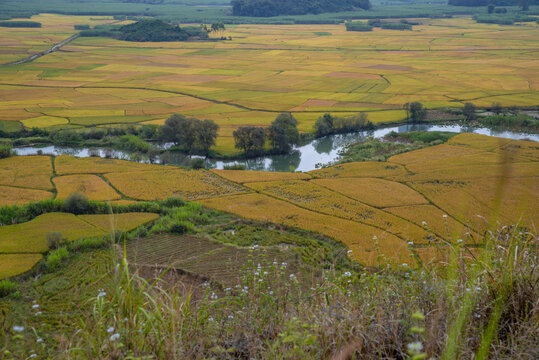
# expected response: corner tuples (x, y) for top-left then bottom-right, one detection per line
(232, 0), (371, 17)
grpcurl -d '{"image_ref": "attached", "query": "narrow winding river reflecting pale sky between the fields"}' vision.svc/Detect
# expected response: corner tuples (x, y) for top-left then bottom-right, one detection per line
(14, 124), (539, 171)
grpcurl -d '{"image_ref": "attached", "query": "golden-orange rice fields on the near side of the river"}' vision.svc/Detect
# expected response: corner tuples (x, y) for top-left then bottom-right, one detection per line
(0, 134), (539, 265)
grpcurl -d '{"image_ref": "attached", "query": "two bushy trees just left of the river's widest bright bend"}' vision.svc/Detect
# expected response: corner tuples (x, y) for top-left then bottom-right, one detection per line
(233, 113), (299, 155)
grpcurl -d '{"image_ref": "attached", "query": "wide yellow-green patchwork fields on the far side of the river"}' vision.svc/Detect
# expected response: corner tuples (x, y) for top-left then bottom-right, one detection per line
(0, 15), (539, 153)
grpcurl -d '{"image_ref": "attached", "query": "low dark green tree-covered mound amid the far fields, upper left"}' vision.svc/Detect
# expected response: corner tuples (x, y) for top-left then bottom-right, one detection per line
(81, 19), (208, 42)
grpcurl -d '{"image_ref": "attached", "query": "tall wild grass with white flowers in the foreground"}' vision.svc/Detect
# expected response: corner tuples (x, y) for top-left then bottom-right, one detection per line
(57, 226), (539, 359)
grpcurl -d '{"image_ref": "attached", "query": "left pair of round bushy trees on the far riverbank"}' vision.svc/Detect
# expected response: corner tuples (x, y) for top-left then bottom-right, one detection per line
(160, 114), (219, 155)
